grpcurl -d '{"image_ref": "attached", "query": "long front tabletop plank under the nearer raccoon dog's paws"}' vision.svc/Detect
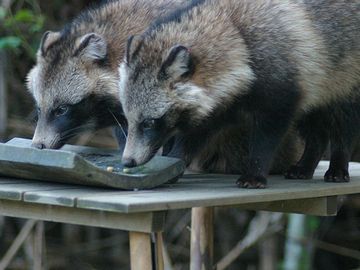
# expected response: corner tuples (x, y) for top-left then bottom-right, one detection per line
(77, 162), (360, 213)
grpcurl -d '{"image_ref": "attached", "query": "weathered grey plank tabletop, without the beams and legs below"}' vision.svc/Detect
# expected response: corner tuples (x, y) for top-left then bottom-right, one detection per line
(0, 161), (360, 213)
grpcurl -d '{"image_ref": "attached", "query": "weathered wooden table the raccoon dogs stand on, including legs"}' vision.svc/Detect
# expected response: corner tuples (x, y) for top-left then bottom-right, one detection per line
(0, 162), (360, 270)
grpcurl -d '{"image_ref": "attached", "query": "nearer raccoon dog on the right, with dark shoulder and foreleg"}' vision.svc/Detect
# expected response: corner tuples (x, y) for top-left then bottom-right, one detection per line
(119, 0), (360, 187)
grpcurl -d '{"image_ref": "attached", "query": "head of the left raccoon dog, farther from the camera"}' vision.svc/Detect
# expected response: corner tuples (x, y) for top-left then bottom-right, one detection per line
(28, 32), (121, 149)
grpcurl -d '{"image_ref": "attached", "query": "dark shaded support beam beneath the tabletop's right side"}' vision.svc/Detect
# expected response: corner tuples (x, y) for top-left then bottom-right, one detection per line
(238, 196), (337, 216)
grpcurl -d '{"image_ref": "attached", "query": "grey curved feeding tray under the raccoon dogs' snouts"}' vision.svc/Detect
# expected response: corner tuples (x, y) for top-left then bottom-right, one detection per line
(0, 138), (185, 190)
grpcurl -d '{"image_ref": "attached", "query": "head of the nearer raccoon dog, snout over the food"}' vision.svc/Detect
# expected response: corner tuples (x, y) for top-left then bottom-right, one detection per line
(119, 36), (207, 167)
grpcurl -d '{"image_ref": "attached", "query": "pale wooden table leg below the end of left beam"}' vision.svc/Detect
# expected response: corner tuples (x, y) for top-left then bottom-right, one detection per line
(129, 232), (155, 270)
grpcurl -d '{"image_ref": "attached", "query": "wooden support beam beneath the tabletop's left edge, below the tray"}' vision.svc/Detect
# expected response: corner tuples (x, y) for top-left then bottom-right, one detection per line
(0, 200), (165, 232)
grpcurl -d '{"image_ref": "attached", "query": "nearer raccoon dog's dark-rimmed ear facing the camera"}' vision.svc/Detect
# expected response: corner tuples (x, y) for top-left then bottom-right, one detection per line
(158, 45), (195, 80)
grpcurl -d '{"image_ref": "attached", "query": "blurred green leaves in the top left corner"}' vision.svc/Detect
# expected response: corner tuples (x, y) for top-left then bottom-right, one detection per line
(0, 0), (45, 58)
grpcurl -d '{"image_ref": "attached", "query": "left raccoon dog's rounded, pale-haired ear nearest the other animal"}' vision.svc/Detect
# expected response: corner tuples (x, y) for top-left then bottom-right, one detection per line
(74, 33), (107, 60)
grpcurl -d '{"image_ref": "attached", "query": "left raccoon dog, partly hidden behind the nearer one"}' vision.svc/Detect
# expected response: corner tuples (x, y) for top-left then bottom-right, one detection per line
(28, 0), (187, 149)
